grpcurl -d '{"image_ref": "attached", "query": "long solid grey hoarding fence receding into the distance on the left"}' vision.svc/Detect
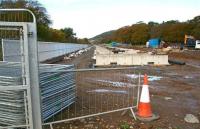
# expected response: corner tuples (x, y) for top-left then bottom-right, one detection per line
(2, 40), (88, 62)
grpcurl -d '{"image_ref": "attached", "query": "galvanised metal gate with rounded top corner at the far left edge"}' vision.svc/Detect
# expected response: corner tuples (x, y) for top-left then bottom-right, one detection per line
(0, 9), (35, 128)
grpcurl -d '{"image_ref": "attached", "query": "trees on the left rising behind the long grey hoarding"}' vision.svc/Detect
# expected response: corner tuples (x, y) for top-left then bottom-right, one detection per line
(0, 0), (89, 43)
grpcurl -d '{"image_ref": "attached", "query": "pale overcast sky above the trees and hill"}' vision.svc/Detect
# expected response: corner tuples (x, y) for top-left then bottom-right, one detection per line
(38, 0), (200, 38)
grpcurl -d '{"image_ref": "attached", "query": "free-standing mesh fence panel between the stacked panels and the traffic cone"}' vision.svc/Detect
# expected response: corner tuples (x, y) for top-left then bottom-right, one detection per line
(43, 68), (140, 129)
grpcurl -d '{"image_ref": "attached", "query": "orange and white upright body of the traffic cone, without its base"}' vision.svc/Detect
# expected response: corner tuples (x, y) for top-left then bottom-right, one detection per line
(137, 74), (153, 117)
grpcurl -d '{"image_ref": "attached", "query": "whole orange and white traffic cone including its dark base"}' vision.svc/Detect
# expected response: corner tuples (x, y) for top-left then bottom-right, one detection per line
(137, 74), (159, 121)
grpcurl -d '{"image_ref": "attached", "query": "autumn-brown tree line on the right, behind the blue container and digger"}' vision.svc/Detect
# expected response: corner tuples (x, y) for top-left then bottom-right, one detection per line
(100, 16), (200, 45)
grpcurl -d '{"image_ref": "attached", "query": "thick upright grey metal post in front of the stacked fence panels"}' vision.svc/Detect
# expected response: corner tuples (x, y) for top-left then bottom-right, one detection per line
(28, 23), (42, 129)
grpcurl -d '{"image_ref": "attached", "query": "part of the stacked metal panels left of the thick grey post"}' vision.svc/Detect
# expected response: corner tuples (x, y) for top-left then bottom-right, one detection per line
(0, 63), (28, 125)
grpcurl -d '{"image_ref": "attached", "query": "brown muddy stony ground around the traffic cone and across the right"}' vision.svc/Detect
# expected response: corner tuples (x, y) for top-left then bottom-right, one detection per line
(45, 49), (200, 129)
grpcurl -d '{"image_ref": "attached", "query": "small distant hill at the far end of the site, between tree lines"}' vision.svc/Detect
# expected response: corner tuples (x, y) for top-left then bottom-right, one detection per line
(90, 30), (115, 43)
